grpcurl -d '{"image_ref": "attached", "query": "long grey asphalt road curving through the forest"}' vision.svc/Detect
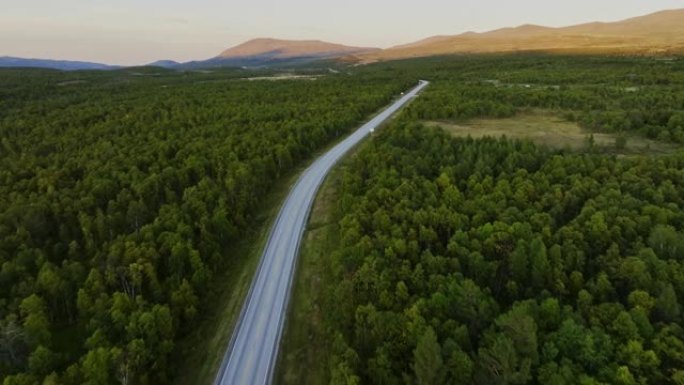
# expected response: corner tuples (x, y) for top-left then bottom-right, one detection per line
(214, 80), (428, 385)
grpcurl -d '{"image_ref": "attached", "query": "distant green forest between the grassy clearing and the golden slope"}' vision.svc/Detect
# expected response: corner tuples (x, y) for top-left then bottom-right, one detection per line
(405, 55), (684, 144)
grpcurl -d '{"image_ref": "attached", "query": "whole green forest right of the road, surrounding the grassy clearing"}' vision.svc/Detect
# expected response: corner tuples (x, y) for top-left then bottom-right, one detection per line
(298, 56), (684, 385)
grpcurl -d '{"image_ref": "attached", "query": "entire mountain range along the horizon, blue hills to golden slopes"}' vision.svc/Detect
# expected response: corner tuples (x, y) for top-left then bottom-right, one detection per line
(0, 9), (684, 70)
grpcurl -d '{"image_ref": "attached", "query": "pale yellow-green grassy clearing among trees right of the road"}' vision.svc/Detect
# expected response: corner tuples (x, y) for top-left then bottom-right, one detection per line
(425, 111), (678, 155)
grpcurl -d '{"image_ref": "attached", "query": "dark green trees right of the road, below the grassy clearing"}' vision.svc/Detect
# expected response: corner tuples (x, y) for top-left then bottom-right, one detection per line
(324, 119), (684, 384)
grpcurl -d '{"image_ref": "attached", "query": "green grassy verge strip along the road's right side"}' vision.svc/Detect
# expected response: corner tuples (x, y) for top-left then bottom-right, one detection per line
(276, 157), (342, 385)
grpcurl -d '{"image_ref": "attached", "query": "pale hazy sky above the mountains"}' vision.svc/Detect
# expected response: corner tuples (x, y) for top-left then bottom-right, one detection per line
(0, 0), (684, 65)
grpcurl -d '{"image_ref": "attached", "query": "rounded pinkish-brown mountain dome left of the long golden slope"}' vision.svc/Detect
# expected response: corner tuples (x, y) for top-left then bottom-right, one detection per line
(218, 39), (378, 59)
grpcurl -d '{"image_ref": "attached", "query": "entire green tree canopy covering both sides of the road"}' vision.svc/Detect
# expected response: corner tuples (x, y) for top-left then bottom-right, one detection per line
(0, 55), (684, 385)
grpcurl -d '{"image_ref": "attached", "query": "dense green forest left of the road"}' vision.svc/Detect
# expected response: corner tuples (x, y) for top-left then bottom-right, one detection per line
(0, 68), (414, 385)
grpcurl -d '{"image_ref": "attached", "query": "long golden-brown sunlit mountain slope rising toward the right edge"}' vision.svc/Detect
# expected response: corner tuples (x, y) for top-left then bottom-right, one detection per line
(356, 9), (684, 62)
